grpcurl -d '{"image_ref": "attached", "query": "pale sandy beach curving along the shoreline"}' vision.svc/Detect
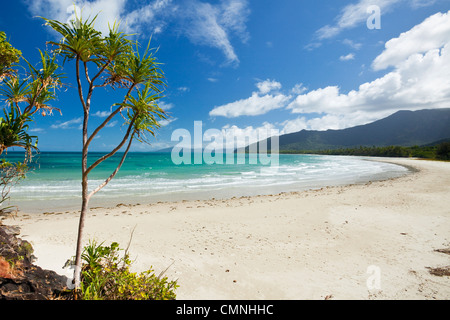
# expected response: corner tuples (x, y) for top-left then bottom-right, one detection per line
(3, 159), (450, 300)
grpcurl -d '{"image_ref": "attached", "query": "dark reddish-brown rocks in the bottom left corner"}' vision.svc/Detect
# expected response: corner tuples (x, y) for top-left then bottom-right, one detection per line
(0, 222), (67, 300)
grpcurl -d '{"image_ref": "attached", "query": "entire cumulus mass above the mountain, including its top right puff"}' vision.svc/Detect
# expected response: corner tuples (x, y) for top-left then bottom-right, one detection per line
(285, 12), (450, 131)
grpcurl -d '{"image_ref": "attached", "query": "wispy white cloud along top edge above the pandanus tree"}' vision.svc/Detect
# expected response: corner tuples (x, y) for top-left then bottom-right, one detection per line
(26, 0), (250, 64)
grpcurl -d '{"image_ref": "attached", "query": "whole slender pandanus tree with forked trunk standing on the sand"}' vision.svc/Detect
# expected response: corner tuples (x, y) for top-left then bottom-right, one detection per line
(44, 16), (166, 290)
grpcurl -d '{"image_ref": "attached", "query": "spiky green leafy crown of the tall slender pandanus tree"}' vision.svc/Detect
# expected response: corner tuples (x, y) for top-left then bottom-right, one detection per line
(43, 16), (167, 144)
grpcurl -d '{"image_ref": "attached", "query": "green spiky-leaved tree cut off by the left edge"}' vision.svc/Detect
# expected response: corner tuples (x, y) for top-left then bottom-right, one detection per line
(0, 32), (62, 211)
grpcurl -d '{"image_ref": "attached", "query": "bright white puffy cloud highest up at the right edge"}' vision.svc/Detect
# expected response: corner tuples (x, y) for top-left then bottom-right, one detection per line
(372, 11), (450, 70)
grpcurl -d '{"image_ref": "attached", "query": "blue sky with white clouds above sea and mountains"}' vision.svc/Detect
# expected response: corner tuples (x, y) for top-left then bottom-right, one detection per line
(0, 0), (450, 151)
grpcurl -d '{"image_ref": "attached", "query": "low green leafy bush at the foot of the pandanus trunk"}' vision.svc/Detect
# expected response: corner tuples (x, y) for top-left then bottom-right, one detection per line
(75, 241), (178, 300)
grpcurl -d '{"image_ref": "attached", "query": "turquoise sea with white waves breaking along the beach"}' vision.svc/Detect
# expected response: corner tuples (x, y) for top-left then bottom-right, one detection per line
(1, 152), (408, 212)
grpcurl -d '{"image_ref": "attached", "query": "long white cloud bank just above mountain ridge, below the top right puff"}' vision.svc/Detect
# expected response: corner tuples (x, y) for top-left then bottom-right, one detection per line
(288, 43), (450, 129)
